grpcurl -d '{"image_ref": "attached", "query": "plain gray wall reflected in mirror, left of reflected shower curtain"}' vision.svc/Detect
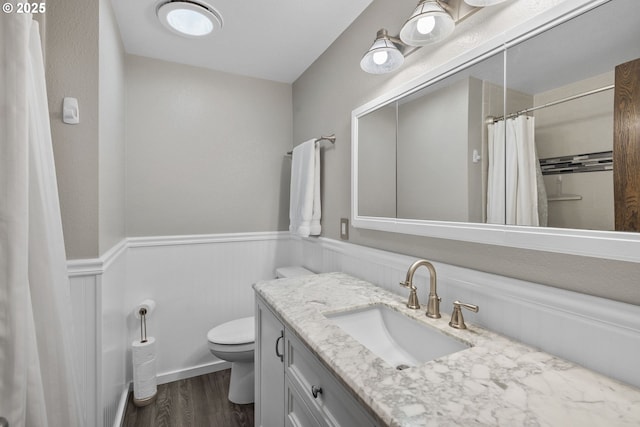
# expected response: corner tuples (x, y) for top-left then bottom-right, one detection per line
(397, 79), (482, 222)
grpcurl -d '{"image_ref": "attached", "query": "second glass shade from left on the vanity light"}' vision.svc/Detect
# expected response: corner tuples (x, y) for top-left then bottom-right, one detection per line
(400, 0), (456, 46)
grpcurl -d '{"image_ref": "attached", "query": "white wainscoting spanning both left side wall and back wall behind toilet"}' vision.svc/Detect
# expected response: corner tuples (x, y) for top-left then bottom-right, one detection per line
(68, 232), (299, 427)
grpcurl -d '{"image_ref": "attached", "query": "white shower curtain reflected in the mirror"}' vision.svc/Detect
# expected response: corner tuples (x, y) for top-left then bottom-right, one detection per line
(487, 116), (547, 226)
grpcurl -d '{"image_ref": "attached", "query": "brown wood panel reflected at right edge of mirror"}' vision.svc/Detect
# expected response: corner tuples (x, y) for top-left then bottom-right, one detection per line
(613, 59), (640, 231)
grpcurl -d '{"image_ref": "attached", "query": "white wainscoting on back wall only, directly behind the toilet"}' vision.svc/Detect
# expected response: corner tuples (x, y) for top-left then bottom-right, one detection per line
(124, 233), (291, 383)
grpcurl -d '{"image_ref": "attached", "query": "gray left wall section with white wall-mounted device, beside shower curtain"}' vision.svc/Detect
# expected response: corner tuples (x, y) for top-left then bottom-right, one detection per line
(44, 0), (125, 259)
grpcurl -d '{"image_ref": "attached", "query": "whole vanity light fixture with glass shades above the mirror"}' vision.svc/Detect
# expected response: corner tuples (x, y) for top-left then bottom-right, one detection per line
(360, 0), (507, 74)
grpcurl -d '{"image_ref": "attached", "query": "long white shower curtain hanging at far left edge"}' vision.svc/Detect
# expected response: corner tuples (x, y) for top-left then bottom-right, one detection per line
(0, 11), (86, 427)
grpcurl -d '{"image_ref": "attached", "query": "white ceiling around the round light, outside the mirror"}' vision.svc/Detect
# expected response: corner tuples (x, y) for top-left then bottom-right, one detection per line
(111, 0), (372, 83)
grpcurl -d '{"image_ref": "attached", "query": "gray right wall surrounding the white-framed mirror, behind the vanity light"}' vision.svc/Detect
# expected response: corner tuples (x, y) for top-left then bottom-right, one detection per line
(293, 0), (640, 304)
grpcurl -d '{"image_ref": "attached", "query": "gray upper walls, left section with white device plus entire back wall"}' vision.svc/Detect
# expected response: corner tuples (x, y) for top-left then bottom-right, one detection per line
(44, 0), (292, 259)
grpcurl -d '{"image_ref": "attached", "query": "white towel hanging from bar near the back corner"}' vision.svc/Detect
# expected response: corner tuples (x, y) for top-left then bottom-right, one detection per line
(289, 139), (321, 237)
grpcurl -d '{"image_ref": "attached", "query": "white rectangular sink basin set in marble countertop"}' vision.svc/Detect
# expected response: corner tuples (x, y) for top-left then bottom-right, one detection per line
(325, 305), (470, 369)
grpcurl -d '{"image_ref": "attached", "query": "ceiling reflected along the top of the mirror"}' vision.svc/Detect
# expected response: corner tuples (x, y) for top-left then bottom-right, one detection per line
(401, 0), (640, 103)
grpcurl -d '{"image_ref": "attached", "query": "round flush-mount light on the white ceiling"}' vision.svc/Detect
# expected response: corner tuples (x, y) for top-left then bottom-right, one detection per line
(156, 0), (222, 37)
